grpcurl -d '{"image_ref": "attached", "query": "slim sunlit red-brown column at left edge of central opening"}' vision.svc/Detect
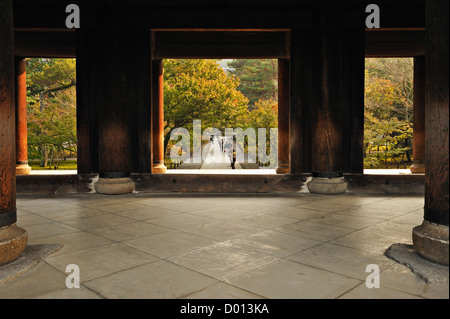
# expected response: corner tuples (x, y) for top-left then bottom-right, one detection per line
(152, 60), (167, 174)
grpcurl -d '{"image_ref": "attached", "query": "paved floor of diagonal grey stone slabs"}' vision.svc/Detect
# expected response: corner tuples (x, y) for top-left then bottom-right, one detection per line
(0, 193), (449, 299)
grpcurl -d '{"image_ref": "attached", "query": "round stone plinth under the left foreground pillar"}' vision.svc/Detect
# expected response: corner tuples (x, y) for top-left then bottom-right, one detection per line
(0, 224), (28, 265)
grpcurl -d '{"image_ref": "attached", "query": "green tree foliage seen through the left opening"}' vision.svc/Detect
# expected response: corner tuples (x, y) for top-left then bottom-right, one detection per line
(27, 59), (77, 168)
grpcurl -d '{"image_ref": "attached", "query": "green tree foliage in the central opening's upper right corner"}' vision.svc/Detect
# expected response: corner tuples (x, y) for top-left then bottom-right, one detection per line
(228, 59), (278, 109)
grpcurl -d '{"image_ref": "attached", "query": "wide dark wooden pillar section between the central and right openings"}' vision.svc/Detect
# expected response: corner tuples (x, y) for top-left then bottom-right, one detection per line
(290, 1), (365, 179)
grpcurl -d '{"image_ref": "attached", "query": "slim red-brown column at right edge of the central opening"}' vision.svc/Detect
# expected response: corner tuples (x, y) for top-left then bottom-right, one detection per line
(276, 59), (290, 174)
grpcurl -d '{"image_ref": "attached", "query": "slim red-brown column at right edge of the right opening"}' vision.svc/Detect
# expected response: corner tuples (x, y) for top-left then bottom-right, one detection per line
(410, 56), (425, 173)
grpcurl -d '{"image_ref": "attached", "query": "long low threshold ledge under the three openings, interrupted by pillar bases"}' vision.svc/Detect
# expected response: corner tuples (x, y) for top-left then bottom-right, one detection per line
(16, 174), (425, 195)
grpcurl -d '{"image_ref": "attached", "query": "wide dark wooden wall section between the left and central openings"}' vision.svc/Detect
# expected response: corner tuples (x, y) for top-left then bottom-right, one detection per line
(76, 26), (152, 176)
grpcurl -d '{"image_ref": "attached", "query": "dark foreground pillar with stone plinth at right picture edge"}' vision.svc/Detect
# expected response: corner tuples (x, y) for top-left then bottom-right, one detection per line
(413, 0), (449, 265)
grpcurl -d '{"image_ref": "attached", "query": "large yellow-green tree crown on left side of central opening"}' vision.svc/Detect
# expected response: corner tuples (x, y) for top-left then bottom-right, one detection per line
(164, 59), (248, 156)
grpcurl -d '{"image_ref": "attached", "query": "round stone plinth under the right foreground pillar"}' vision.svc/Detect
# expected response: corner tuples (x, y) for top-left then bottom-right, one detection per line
(413, 220), (448, 266)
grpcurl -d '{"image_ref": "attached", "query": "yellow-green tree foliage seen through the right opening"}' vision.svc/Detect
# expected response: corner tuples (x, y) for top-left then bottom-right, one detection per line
(364, 58), (414, 168)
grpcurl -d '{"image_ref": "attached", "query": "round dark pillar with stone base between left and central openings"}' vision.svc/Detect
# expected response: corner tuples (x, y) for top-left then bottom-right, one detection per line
(89, 28), (134, 194)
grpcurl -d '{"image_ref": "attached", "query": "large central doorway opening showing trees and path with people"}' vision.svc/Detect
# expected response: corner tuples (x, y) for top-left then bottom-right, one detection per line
(163, 59), (278, 174)
